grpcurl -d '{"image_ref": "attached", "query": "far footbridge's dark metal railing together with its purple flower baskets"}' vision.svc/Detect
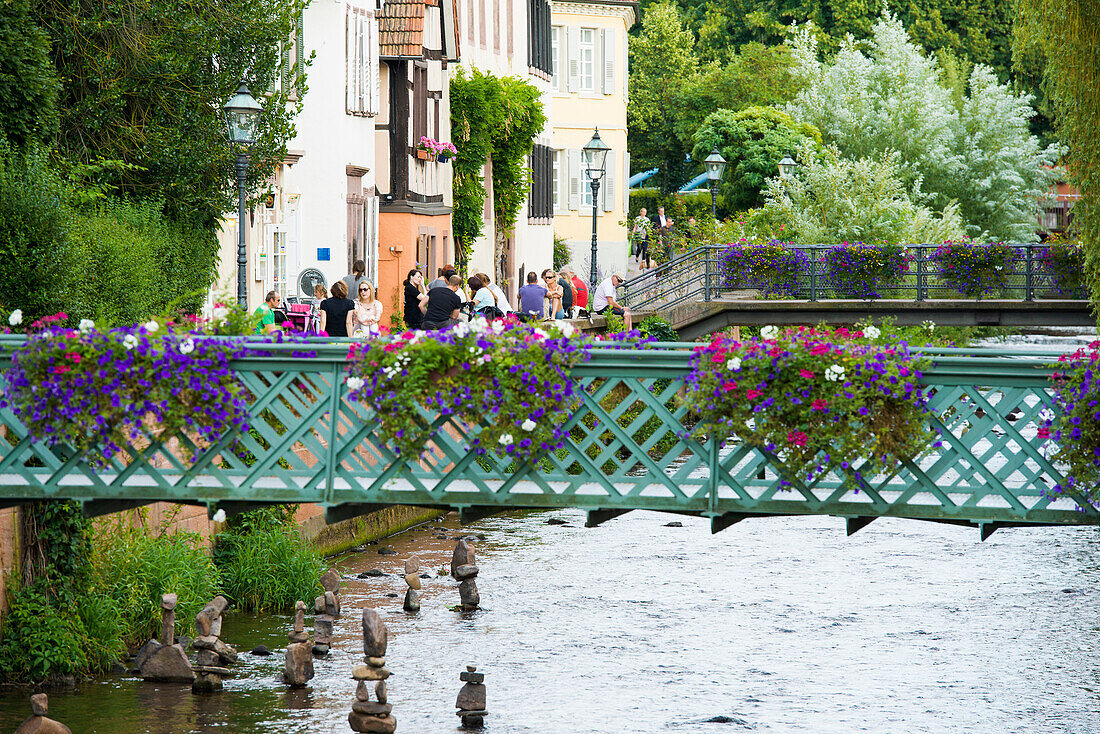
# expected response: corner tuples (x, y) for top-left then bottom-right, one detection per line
(622, 242), (1088, 309)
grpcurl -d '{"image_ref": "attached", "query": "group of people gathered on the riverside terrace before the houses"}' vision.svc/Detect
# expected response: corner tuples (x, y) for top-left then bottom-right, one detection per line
(256, 260), (630, 338)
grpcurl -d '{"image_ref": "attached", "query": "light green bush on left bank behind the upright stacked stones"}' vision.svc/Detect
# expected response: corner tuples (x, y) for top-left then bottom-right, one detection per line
(89, 519), (221, 645)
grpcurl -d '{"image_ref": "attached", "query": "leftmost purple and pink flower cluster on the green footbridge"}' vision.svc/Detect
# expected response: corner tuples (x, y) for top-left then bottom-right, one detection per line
(2, 315), (249, 464)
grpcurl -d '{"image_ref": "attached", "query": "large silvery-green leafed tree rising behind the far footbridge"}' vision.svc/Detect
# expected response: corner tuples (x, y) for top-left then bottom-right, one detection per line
(788, 13), (1059, 241)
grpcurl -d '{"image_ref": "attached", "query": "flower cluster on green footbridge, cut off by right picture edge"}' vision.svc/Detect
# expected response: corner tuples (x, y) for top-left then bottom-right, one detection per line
(1038, 341), (1100, 507)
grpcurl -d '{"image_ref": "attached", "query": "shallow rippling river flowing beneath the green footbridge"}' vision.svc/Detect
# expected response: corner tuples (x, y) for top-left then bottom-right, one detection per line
(0, 511), (1100, 734)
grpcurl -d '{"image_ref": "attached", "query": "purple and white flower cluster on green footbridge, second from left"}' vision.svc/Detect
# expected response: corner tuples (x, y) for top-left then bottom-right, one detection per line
(348, 319), (586, 459)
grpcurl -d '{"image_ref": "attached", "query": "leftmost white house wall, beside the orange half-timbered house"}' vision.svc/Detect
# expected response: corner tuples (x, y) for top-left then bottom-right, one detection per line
(218, 0), (380, 308)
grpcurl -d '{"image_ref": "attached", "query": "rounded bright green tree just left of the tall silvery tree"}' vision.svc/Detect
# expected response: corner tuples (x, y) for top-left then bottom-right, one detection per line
(692, 107), (822, 211)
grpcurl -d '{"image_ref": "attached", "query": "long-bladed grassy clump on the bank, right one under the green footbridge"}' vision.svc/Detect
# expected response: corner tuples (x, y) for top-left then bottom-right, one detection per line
(215, 506), (326, 612)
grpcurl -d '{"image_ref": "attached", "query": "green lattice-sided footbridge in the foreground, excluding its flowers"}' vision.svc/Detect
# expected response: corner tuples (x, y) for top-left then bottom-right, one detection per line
(0, 343), (1100, 539)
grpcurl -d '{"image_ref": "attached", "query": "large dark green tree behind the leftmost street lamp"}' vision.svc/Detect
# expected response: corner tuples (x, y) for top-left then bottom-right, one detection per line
(34, 0), (307, 229)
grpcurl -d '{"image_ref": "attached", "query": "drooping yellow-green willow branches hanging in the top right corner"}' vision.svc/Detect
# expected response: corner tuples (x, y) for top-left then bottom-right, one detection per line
(1016, 0), (1100, 314)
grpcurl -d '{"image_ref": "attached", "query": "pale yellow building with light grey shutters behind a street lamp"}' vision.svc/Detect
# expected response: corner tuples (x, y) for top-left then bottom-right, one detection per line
(550, 0), (638, 280)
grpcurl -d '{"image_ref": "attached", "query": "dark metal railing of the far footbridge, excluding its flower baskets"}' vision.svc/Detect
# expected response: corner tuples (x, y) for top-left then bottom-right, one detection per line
(622, 243), (1088, 309)
